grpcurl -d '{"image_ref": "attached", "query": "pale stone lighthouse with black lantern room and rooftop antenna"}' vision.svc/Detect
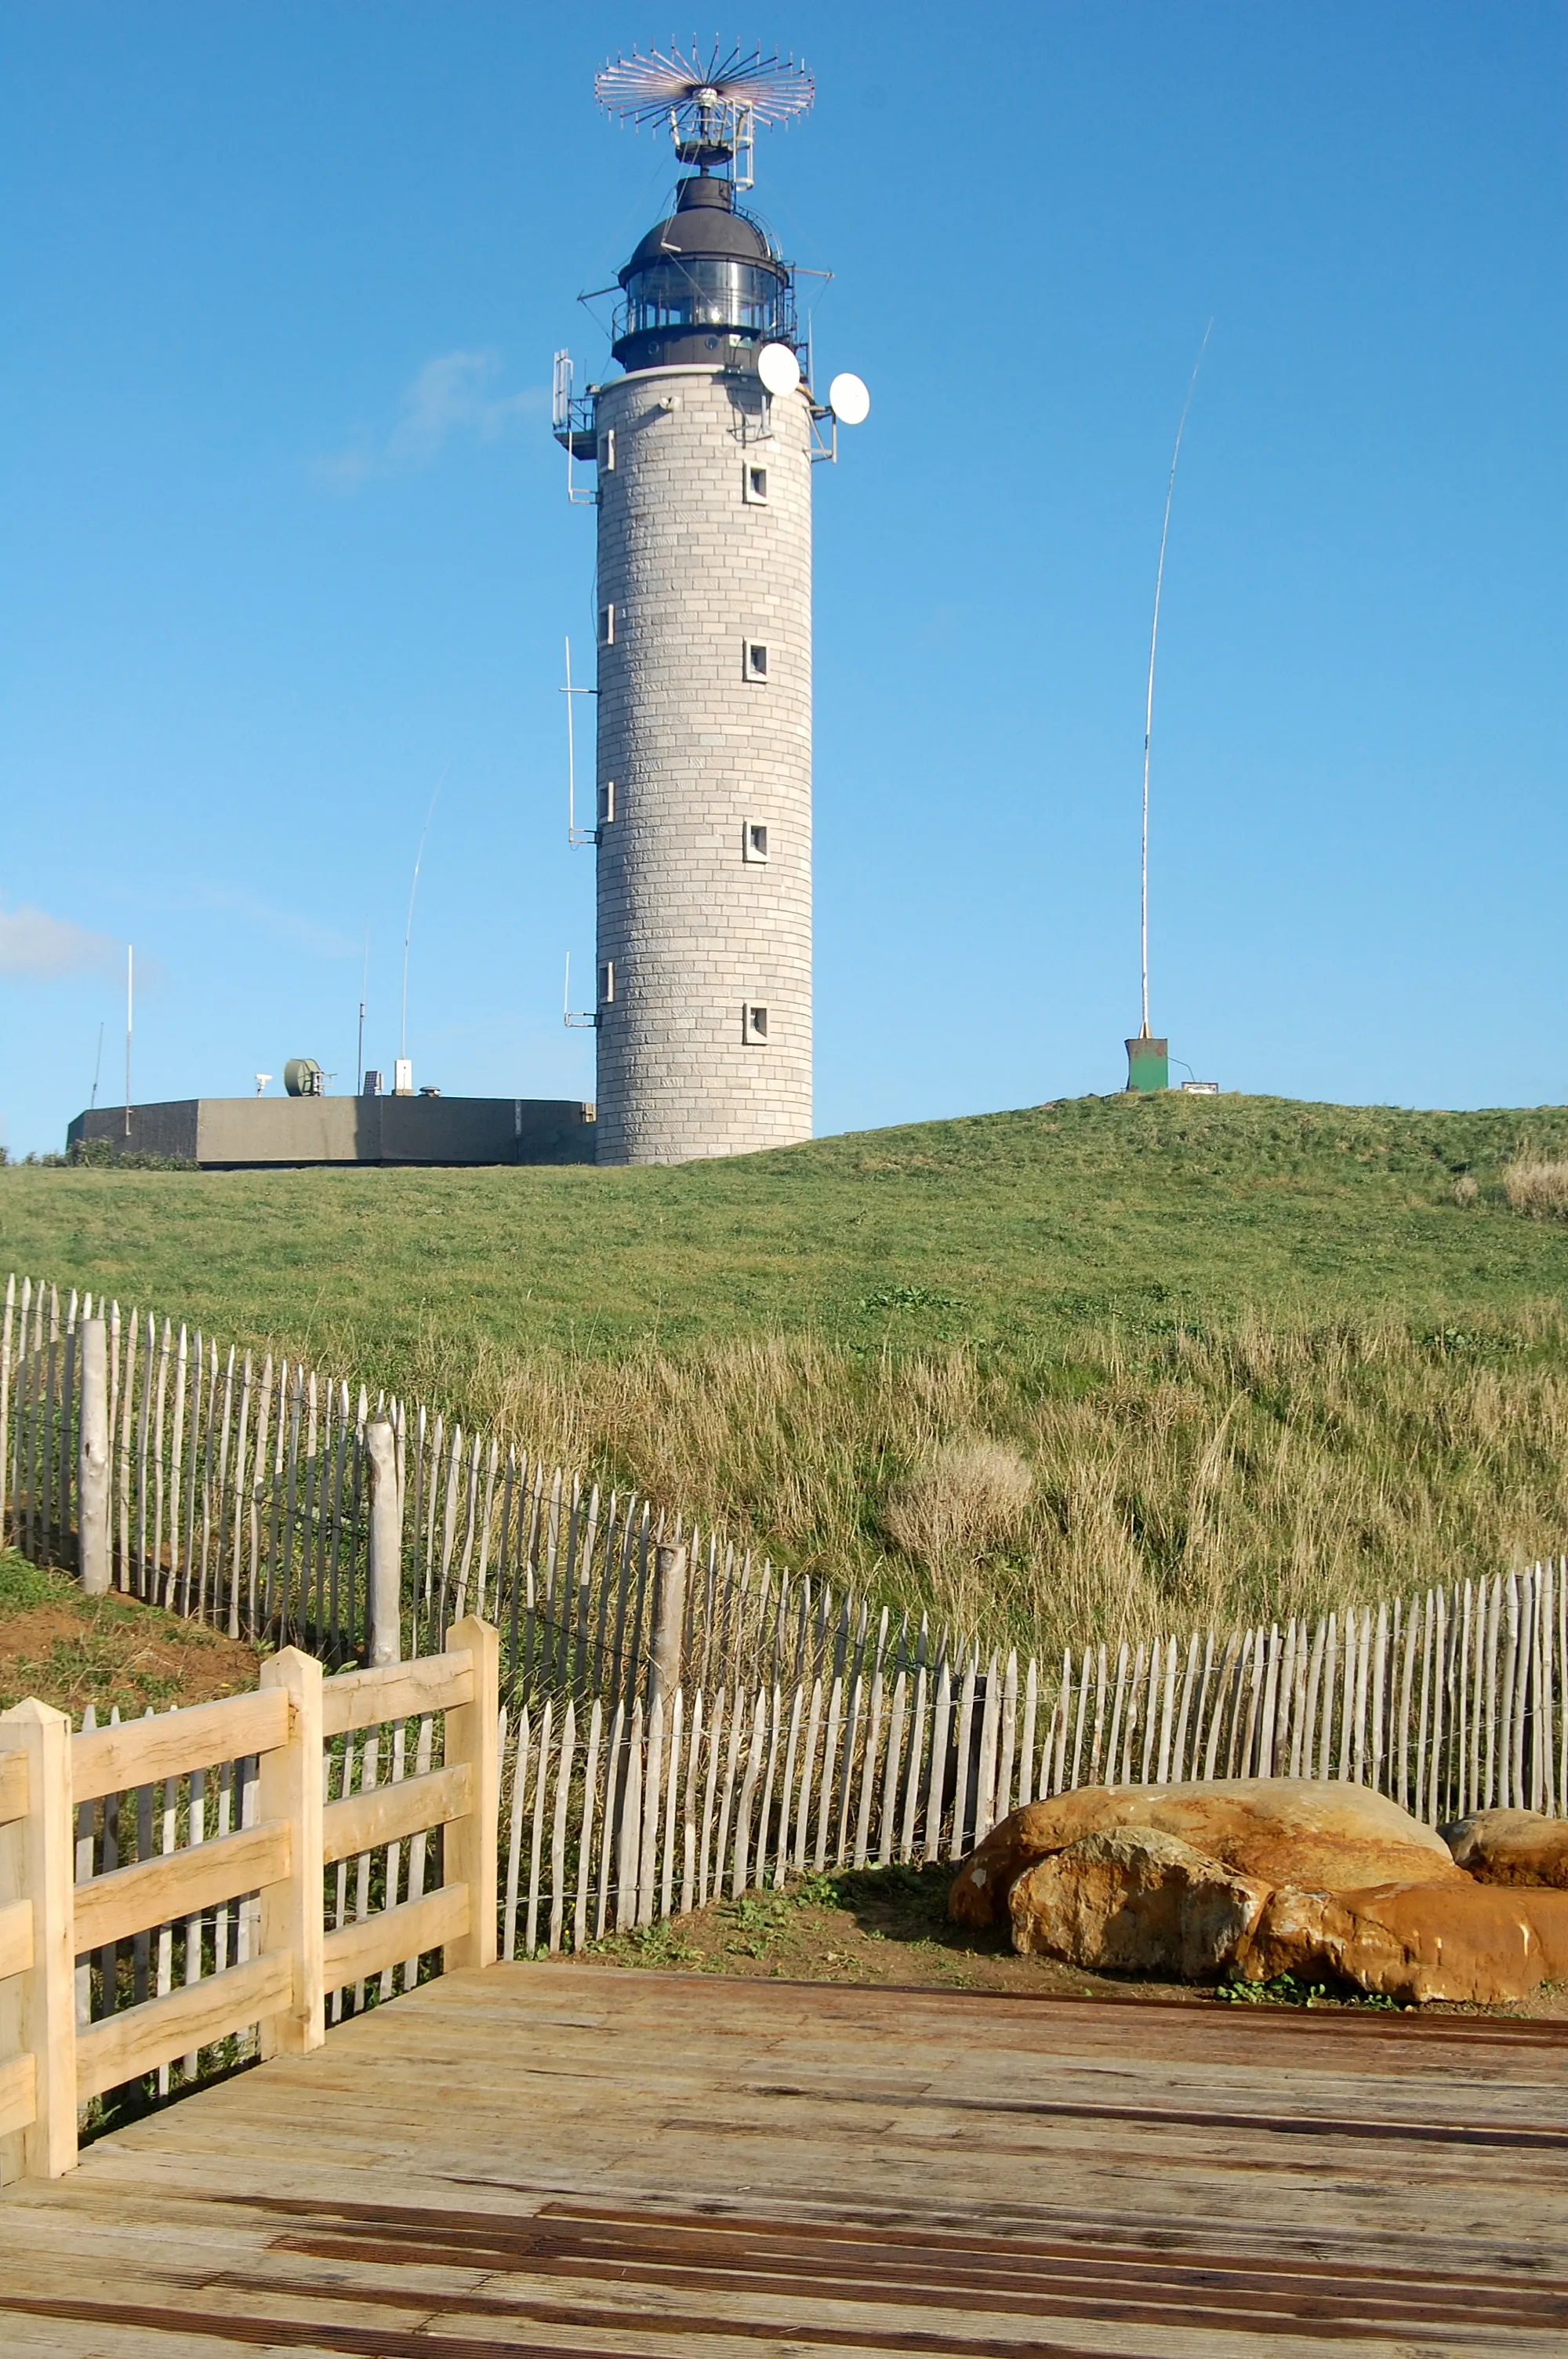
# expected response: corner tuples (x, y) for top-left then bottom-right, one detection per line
(557, 56), (858, 1163)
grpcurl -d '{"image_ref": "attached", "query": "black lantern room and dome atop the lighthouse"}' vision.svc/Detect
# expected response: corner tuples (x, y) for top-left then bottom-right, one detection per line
(611, 173), (795, 370)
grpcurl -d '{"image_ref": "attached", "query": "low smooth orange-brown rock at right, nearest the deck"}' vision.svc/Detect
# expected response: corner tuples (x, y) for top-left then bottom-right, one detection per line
(1233, 1875), (1568, 2005)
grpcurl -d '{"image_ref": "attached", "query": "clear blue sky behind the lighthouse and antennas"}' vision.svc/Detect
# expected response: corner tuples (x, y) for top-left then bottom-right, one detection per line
(0, 0), (1568, 1154)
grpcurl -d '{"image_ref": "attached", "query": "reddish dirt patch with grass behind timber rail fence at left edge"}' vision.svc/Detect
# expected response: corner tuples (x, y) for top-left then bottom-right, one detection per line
(0, 1554), (262, 1720)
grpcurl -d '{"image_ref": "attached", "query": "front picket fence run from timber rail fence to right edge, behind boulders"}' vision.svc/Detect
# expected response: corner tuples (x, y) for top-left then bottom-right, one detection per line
(500, 1559), (1568, 1958)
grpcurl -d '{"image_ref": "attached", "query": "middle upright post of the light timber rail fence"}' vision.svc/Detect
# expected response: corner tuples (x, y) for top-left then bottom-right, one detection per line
(257, 1647), (328, 2057)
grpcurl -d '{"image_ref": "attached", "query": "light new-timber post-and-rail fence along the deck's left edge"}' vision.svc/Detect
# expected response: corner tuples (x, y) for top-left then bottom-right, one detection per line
(0, 1618), (500, 2177)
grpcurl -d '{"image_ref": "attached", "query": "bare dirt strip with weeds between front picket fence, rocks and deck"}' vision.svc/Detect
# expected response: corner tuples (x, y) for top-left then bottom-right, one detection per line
(568, 1866), (1568, 2019)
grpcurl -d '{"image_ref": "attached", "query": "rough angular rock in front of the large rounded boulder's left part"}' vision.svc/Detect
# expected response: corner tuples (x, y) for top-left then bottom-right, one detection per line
(1009, 1826), (1269, 1982)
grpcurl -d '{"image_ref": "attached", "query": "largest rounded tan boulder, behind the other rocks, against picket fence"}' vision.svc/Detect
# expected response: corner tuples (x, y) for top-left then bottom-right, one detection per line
(948, 1776), (1467, 1925)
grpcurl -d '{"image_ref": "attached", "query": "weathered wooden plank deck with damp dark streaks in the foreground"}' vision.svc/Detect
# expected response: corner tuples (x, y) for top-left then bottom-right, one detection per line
(0, 1965), (1568, 2359)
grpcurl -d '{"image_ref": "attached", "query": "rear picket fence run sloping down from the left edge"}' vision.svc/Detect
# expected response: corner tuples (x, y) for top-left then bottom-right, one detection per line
(0, 1276), (886, 1703)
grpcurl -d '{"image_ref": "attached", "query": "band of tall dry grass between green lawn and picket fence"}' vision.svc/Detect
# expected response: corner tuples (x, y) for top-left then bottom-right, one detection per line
(398, 1311), (1568, 1647)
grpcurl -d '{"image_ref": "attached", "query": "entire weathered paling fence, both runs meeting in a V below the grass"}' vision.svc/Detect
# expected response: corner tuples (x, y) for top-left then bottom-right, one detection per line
(0, 1281), (1568, 1979)
